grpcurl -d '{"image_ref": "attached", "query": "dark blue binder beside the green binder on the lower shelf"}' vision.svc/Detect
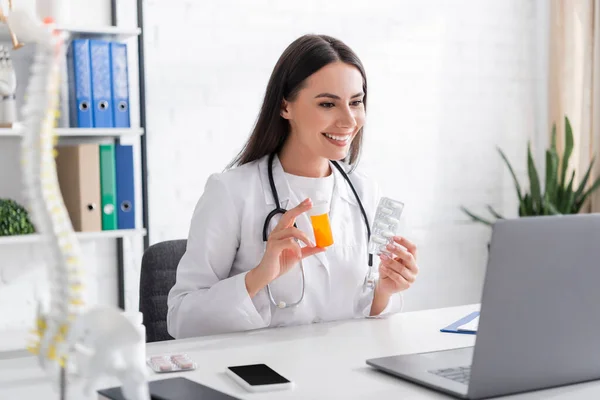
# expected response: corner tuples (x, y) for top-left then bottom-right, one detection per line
(115, 144), (135, 229)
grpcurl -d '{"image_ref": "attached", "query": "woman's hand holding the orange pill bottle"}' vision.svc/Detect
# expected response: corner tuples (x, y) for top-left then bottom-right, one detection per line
(246, 199), (325, 297)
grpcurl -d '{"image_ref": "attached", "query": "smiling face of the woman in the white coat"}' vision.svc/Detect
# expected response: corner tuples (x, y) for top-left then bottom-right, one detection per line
(281, 62), (365, 160)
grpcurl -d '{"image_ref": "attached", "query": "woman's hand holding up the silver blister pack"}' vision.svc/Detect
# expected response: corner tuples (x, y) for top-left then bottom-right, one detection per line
(376, 236), (419, 297)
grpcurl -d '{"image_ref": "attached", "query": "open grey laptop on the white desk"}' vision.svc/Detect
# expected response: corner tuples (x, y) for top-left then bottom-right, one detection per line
(366, 214), (600, 399)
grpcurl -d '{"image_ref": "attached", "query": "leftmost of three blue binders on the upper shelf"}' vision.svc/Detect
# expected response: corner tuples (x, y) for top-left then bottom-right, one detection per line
(67, 39), (94, 128)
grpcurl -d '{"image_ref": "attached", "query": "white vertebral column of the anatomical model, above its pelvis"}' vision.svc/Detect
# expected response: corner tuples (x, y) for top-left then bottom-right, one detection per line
(6, 4), (84, 372)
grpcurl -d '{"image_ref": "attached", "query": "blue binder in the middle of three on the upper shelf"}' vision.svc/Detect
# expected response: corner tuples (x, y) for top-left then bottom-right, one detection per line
(90, 39), (114, 128)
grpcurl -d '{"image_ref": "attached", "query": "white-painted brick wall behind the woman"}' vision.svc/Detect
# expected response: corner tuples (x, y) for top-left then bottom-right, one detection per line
(144, 0), (548, 310)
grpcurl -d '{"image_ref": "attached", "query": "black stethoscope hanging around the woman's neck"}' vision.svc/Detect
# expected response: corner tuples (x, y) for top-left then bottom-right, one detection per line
(263, 153), (374, 308)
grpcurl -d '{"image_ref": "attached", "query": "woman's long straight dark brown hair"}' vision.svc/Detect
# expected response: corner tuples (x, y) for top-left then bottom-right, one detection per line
(228, 35), (367, 168)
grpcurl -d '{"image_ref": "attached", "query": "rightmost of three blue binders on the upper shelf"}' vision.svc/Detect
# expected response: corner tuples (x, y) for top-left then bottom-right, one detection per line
(110, 42), (130, 128)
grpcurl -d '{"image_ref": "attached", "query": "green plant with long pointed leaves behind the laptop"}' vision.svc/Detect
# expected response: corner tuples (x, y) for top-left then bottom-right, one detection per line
(461, 117), (600, 226)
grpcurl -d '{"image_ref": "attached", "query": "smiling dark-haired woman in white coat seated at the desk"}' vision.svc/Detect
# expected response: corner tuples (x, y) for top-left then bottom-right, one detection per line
(167, 35), (418, 338)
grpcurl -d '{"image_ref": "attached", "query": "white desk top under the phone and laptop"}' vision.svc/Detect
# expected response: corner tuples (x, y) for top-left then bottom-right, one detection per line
(0, 305), (600, 400)
